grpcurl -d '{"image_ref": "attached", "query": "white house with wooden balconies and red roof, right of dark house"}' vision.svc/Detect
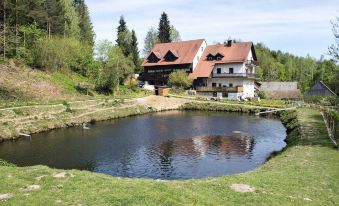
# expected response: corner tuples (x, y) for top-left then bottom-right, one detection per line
(190, 41), (257, 99)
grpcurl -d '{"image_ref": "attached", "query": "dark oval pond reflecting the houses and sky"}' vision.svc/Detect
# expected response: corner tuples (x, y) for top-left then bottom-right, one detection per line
(0, 111), (286, 179)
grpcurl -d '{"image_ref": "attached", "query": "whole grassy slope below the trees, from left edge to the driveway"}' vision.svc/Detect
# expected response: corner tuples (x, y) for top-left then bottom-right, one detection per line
(0, 63), (148, 108)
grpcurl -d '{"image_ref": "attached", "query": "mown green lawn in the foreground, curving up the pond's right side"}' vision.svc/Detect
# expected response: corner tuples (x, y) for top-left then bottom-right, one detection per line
(0, 108), (339, 206)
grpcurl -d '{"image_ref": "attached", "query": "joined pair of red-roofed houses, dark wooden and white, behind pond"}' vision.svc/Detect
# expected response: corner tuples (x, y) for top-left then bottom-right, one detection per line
(143, 39), (257, 99)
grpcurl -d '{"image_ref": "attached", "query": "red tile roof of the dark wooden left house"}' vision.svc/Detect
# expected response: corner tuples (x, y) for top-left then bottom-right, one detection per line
(142, 39), (205, 67)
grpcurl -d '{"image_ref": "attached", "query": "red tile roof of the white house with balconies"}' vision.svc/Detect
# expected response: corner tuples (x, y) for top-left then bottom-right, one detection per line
(190, 42), (253, 79)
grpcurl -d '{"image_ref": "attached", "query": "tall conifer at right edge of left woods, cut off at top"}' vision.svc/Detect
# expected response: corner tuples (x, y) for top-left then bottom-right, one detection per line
(74, 0), (94, 46)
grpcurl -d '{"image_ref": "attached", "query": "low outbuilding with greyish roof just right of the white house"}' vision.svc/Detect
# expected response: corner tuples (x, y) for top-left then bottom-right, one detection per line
(256, 82), (301, 99)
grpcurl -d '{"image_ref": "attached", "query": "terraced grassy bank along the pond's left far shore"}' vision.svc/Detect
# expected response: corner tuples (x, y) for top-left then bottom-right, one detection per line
(0, 99), (152, 139)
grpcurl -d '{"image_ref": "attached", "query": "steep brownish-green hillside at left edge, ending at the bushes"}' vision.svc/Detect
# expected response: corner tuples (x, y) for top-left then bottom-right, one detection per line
(0, 64), (94, 103)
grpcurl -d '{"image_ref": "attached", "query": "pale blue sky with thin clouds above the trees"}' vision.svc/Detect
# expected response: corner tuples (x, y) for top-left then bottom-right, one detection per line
(85, 0), (339, 58)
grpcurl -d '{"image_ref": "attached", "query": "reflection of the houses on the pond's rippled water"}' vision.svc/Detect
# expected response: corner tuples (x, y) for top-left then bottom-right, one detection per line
(148, 135), (255, 178)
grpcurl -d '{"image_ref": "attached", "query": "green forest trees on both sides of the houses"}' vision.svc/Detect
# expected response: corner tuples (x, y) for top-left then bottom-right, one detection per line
(0, 0), (339, 94)
